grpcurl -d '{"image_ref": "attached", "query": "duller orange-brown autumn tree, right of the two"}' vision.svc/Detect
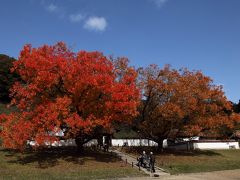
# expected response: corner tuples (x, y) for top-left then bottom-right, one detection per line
(139, 65), (240, 148)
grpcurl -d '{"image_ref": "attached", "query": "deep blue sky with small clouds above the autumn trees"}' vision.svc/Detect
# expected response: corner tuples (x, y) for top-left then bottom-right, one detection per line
(0, 0), (240, 102)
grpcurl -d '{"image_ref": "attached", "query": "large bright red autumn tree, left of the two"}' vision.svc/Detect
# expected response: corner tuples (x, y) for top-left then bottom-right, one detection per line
(0, 42), (139, 149)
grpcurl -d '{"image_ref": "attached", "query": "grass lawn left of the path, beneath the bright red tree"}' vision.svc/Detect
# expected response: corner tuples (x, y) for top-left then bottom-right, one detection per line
(0, 148), (144, 179)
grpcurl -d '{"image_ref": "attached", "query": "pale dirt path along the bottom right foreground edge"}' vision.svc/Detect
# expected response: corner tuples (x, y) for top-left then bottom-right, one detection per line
(118, 169), (240, 180)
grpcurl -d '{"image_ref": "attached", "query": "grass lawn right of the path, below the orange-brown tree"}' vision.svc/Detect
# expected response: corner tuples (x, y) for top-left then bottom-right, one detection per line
(121, 146), (240, 174)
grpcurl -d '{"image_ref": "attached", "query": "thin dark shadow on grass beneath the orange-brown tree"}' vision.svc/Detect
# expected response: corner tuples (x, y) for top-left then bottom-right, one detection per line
(122, 146), (222, 156)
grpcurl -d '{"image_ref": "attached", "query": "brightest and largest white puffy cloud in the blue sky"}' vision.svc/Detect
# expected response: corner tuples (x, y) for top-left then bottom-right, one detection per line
(84, 16), (107, 31)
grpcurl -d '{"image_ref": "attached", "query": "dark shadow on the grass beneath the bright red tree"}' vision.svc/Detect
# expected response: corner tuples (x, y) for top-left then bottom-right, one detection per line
(0, 147), (120, 168)
